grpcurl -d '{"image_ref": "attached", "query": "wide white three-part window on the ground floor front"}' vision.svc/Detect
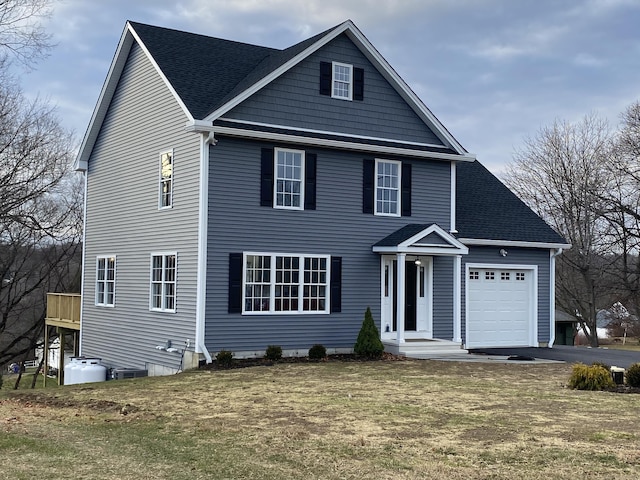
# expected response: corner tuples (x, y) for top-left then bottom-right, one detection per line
(243, 253), (330, 313)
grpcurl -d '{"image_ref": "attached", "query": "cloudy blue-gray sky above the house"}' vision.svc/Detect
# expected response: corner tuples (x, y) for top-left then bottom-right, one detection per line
(13, 0), (640, 173)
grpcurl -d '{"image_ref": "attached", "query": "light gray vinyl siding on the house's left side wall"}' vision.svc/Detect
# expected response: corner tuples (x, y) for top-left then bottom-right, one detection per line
(81, 44), (199, 368)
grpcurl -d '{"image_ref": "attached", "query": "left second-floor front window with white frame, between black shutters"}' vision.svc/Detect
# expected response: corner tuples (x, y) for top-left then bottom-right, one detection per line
(273, 148), (304, 210)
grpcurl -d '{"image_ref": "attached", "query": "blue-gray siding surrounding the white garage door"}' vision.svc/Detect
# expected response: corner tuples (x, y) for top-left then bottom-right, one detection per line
(462, 246), (551, 343)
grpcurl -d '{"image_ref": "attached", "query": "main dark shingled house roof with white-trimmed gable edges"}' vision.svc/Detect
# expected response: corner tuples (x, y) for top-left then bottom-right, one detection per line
(76, 20), (473, 170)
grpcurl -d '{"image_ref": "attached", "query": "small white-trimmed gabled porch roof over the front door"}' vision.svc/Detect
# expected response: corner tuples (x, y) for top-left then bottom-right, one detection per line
(373, 223), (469, 256)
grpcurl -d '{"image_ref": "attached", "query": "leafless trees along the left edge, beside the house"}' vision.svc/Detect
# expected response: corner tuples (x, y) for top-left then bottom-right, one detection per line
(0, 0), (82, 365)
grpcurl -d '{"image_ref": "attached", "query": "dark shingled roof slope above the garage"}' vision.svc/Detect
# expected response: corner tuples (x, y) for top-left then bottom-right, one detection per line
(456, 160), (570, 248)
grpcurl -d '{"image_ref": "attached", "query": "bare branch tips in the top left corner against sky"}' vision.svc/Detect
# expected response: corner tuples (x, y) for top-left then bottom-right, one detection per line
(0, 0), (52, 66)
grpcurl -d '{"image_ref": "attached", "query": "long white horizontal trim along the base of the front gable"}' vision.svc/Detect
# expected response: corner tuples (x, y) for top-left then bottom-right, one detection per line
(185, 122), (475, 162)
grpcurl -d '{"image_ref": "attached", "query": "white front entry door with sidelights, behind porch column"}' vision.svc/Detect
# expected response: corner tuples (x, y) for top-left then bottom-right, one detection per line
(381, 255), (433, 339)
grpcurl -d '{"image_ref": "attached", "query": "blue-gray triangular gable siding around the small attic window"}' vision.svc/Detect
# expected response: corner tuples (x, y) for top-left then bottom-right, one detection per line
(224, 34), (443, 145)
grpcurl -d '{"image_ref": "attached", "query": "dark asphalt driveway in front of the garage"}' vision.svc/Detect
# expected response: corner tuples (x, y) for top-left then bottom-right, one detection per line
(469, 345), (640, 368)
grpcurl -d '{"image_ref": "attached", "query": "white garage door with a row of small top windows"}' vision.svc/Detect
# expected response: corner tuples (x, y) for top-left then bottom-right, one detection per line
(466, 267), (535, 348)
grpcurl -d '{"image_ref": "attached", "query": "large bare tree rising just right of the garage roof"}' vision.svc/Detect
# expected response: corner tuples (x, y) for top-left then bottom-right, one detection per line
(504, 115), (613, 346)
